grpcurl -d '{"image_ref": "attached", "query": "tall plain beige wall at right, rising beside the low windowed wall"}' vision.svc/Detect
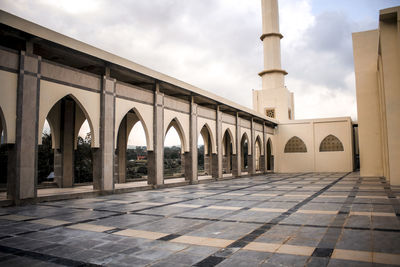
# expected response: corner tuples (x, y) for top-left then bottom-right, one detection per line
(353, 30), (383, 176)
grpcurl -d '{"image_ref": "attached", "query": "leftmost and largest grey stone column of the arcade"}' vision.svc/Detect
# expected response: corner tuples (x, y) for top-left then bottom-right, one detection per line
(7, 51), (41, 204)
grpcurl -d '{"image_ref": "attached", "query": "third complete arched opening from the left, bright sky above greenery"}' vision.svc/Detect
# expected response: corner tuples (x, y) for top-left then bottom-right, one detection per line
(164, 118), (185, 183)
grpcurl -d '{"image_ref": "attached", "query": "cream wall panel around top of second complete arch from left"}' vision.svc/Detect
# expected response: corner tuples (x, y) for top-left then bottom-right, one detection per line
(114, 98), (153, 151)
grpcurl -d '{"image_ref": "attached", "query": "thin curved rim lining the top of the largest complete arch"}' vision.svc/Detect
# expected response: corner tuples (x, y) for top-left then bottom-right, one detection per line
(38, 93), (98, 147)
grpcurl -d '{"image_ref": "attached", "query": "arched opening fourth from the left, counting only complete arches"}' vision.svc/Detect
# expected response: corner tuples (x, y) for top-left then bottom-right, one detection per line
(197, 124), (212, 176)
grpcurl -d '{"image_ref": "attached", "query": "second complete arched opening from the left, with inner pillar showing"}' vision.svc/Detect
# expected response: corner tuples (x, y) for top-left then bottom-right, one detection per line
(114, 109), (148, 184)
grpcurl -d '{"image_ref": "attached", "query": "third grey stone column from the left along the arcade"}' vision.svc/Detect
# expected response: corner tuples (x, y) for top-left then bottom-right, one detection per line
(147, 83), (164, 186)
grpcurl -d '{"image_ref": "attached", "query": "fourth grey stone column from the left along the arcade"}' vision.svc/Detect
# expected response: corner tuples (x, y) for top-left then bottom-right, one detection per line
(185, 96), (198, 184)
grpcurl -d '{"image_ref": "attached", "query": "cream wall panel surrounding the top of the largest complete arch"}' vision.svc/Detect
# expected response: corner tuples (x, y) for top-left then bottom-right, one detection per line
(38, 80), (100, 147)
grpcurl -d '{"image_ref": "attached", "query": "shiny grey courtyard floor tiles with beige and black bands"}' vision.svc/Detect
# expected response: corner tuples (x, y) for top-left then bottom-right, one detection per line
(0, 173), (400, 267)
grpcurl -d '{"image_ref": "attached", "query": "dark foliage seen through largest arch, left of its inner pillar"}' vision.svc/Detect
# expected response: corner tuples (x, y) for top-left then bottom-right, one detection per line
(38, 133), (54, 184)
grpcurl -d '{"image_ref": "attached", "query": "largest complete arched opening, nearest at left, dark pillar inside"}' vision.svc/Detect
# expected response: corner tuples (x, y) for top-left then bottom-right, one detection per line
(37, 95), (93, 187)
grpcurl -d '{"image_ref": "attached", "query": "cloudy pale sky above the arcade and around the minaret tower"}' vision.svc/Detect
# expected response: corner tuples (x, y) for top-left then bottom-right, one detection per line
(0, 0), (400, 147)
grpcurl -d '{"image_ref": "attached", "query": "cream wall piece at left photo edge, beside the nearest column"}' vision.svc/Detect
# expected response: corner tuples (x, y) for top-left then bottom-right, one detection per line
(0, 70), (18, 144)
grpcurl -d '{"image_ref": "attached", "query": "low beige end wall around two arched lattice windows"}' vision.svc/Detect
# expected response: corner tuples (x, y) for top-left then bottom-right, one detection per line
(273, 117), (353, 172)
